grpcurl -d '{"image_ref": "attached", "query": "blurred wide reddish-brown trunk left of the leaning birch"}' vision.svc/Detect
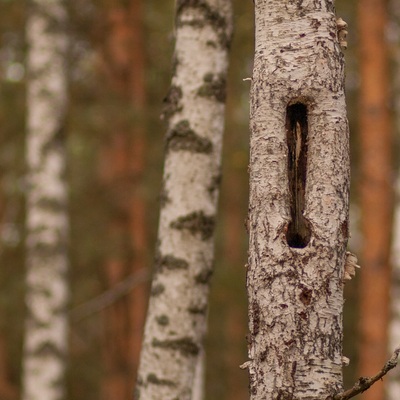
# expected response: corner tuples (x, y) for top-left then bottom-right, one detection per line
(97, 0), (148, 400)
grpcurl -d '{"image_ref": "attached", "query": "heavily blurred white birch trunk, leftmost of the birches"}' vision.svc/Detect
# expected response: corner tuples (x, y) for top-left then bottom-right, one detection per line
(22, 0), (68, 400)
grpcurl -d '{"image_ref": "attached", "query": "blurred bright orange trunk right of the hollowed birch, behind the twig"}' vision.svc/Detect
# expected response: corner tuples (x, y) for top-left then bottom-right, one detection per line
(358, 0), (393, 400)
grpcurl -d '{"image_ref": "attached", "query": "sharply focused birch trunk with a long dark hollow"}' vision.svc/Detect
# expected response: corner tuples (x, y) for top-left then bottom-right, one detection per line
(244, 0), (349, 400)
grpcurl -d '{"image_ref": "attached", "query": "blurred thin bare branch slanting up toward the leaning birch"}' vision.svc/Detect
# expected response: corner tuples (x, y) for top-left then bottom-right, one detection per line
(70, 268), (150, 322)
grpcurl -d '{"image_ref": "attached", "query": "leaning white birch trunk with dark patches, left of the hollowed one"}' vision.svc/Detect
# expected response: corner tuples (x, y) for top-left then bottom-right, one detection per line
(136, 0), (232, 400)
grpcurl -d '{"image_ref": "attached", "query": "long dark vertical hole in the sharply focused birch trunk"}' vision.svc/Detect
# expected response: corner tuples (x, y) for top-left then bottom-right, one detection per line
(286, 103), (311, 249)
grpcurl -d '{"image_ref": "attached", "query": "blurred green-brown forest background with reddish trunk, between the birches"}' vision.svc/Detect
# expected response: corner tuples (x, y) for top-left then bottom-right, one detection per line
(0, 0), (400, 400)
